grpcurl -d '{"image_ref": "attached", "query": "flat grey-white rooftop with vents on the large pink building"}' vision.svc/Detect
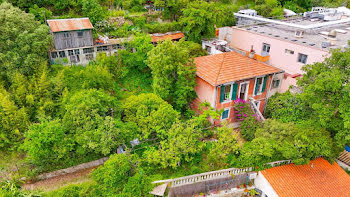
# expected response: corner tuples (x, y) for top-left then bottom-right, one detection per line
(234, 14), (350, 50)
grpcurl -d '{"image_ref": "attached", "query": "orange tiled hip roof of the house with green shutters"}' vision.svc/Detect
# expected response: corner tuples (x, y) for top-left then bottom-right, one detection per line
(194, 52), (282, 85)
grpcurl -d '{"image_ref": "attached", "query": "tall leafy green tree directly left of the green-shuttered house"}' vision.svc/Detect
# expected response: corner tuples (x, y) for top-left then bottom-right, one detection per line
(146, 40), (196, 113)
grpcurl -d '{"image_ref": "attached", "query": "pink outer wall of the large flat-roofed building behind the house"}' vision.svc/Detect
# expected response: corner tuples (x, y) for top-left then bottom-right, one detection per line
(230, 27), (329, 92)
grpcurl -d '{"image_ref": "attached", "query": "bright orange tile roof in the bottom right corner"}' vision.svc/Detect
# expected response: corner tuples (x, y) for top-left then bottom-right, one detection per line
(261, 158), (350, 197)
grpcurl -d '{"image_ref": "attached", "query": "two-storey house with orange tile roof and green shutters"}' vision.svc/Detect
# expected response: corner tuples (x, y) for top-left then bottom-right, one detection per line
(192, 52), (284, 124)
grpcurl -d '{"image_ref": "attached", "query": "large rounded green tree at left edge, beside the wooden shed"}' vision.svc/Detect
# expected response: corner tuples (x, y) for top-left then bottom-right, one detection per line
(0, 2), (52, 86)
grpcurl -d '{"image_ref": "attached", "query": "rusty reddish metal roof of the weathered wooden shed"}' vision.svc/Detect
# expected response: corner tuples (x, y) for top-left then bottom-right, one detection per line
(47, 18), (94, 32)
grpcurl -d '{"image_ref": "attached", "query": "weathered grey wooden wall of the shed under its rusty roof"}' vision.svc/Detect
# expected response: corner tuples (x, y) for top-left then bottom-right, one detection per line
(53, 29), (93, 50)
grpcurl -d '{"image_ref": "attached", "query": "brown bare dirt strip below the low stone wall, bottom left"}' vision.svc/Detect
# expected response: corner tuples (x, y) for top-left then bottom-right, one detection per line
(22, 167), (97, 191)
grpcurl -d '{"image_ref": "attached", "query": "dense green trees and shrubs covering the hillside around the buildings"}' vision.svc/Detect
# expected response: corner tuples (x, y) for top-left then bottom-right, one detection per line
(0, 0), (350, 197)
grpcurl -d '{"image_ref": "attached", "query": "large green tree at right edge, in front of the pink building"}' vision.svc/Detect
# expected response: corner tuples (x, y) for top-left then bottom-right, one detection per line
(298, 49), (350, 147)
